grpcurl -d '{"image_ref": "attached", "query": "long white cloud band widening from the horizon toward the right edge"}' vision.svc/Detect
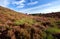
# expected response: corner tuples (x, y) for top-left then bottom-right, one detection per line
(19, 0), (60, 13)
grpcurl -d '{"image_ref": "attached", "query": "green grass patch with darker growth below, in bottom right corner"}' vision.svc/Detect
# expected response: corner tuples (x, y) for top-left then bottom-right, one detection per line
(43, 27), (60, 39)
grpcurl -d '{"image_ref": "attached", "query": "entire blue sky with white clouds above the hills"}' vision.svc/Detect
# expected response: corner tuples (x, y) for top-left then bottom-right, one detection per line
(0, 0), (60, 14)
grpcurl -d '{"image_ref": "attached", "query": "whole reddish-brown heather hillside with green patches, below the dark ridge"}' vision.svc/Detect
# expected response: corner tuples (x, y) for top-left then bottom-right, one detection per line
(0, 6), (60, 39)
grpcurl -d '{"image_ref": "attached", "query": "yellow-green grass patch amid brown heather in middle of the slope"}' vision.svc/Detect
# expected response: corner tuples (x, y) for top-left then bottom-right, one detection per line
(14, 18), (36, 25)
